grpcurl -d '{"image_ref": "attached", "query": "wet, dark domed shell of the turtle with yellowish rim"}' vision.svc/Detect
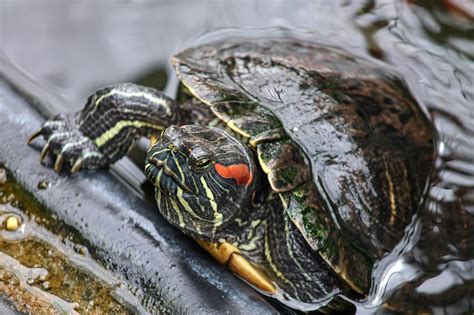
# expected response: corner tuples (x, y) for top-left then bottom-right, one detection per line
(173, 38), (433, 292)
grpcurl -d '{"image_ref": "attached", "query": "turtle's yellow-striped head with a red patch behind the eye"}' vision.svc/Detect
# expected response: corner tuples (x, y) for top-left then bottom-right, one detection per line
(145, 125), (256, 241)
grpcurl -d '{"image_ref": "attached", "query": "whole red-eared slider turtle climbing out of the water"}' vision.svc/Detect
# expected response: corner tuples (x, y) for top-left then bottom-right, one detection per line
(26, 38), (433, 309)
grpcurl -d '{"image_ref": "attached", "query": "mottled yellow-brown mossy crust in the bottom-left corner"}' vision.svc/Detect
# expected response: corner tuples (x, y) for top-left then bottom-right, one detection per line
(0, 165), (131, 314)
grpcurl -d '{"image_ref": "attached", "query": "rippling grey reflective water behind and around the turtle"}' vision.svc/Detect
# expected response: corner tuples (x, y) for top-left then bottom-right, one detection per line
(0, 0), (474, 314)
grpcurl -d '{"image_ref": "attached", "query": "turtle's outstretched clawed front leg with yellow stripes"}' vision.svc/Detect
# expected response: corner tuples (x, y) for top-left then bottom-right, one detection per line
(28, 83), (181, 173)
